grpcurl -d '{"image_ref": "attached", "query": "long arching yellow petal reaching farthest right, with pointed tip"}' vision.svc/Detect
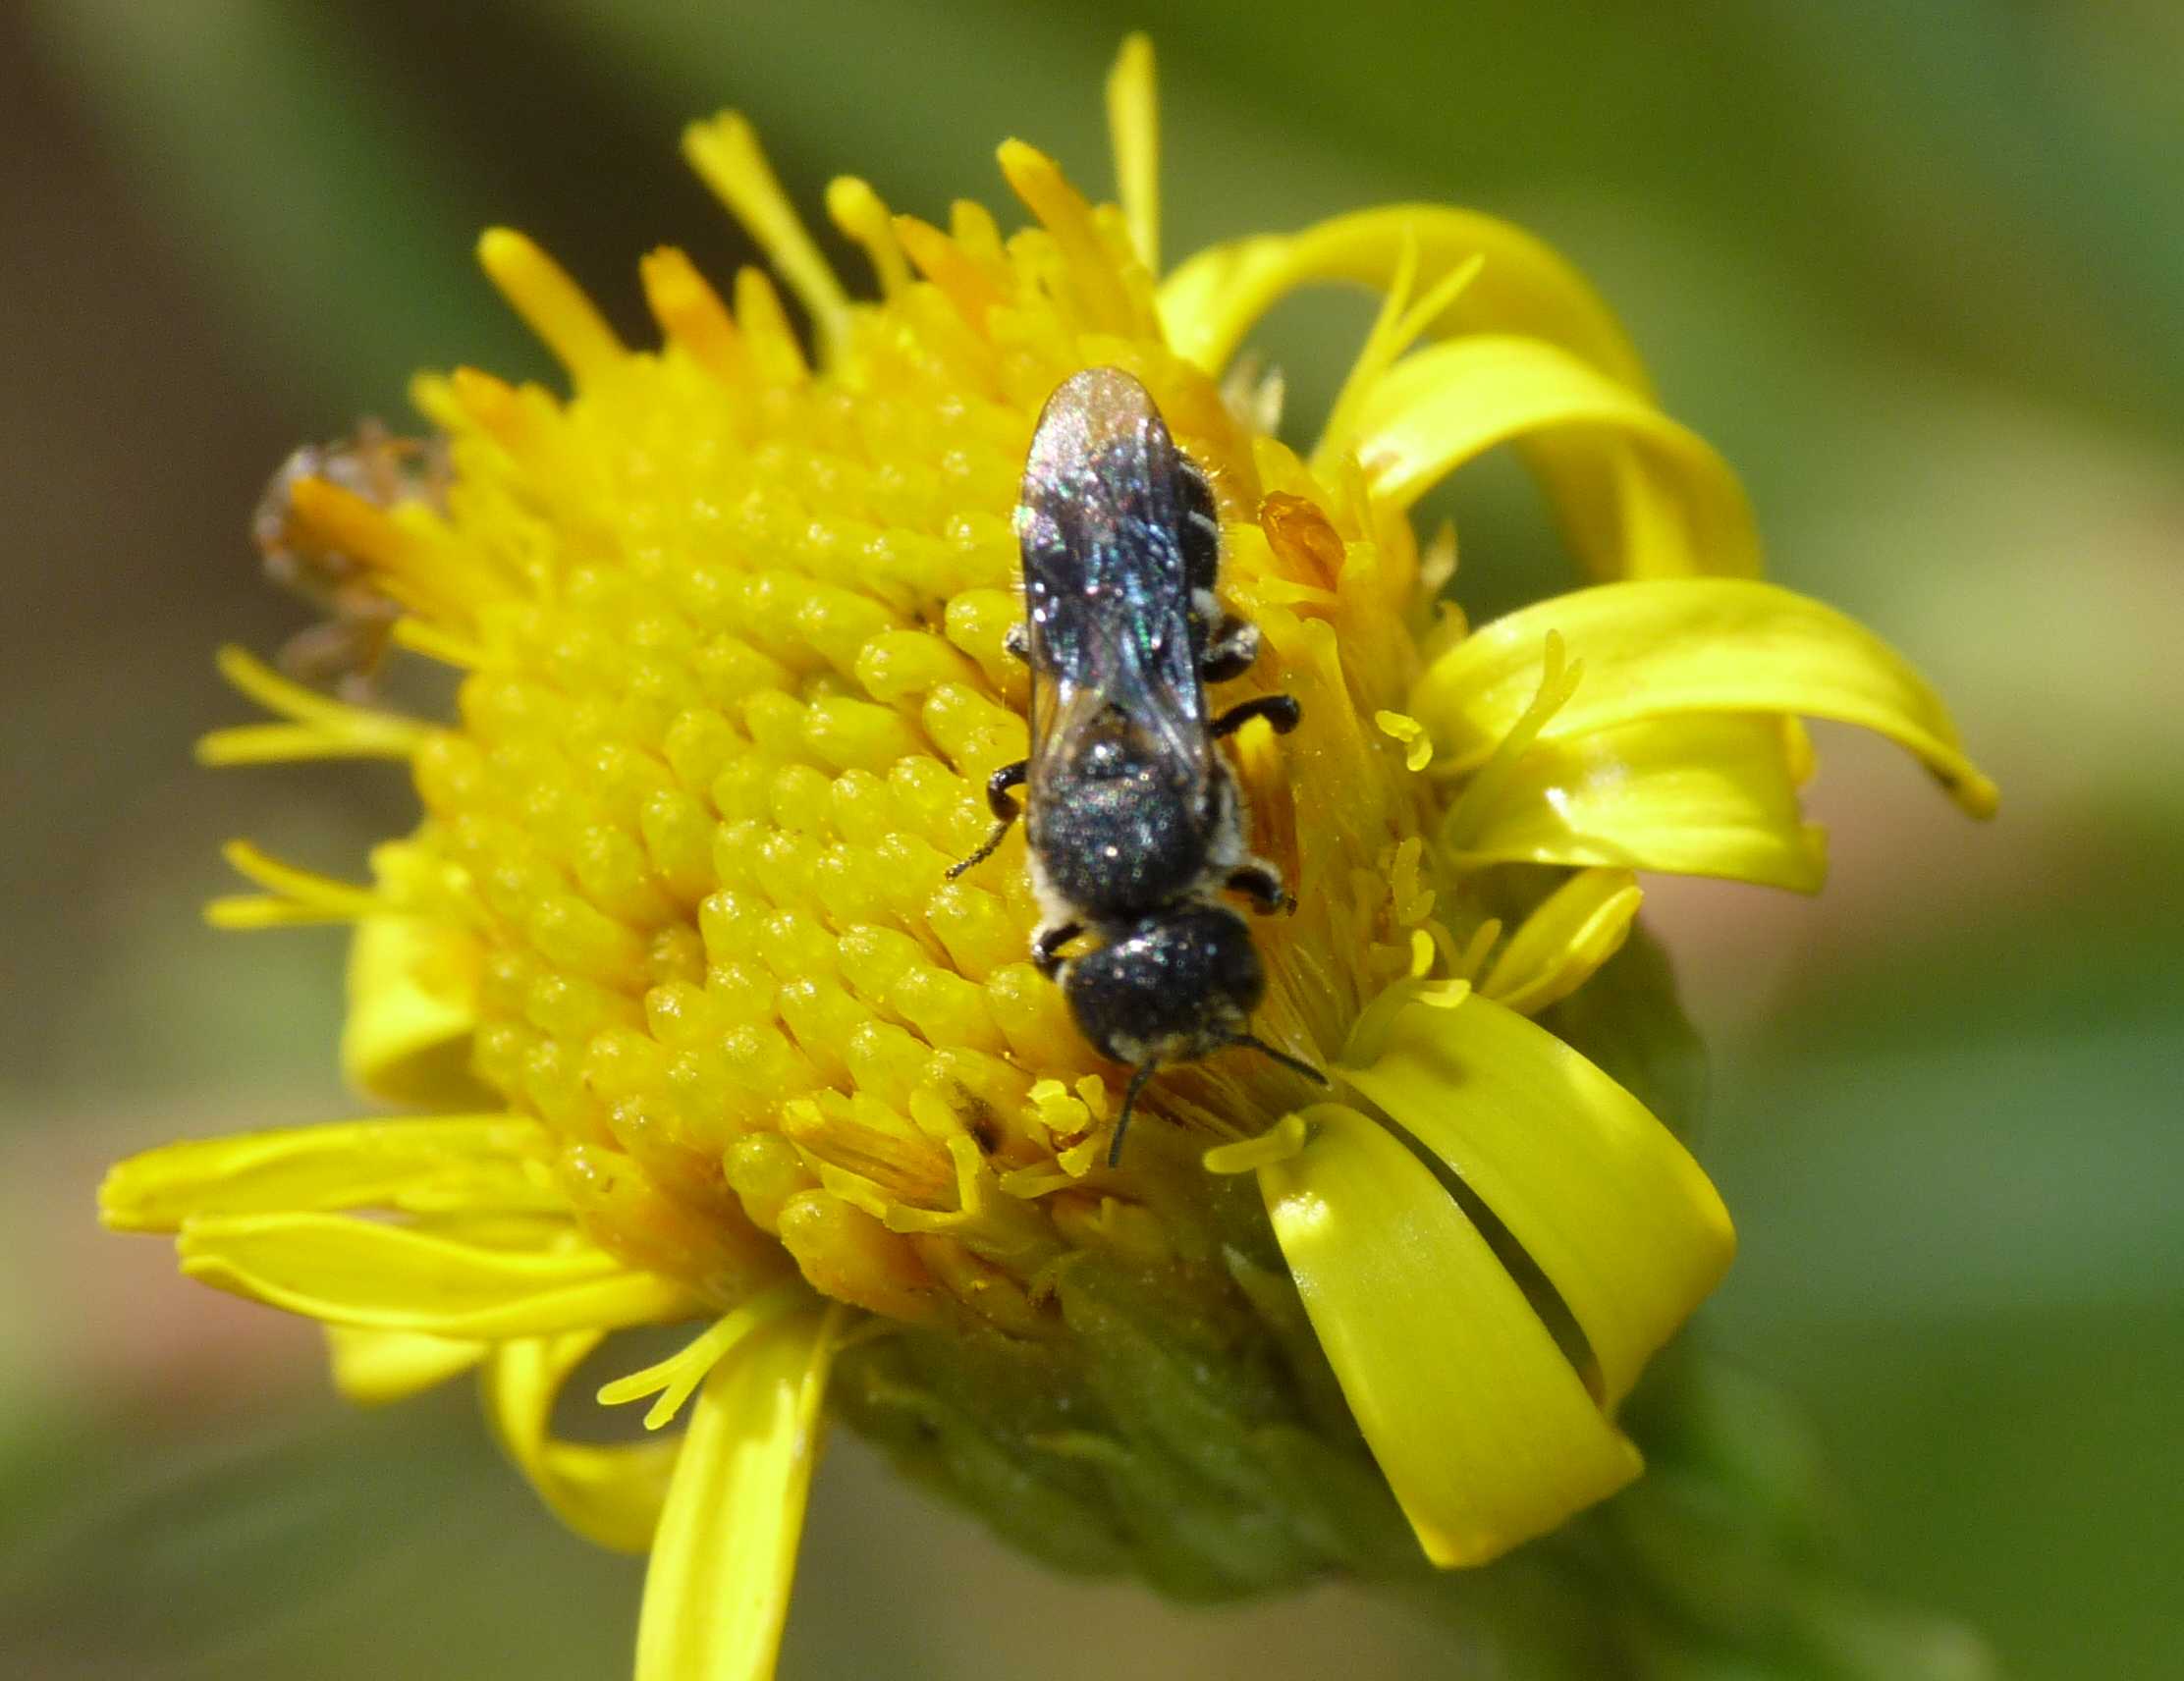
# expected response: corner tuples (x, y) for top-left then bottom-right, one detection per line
(1404, 578), (1996, 817)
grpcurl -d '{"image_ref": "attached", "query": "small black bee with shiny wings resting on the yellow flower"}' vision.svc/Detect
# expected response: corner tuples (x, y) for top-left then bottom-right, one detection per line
(948, 367), (1326, 1166)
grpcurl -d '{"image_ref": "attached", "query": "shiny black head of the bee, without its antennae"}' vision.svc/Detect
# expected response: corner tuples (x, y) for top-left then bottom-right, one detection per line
(1062, 903), (1267, 1063)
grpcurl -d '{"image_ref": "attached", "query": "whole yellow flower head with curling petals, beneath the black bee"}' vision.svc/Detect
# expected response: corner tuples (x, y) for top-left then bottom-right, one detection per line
(103, 41), (1994, 1677)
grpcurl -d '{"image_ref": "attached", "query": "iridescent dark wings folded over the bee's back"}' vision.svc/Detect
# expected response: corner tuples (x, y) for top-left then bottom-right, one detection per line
(1015, 369), (1212, 775)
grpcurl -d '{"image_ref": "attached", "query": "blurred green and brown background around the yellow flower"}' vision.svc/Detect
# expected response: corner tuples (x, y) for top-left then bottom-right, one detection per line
(0, 0), (2184, 1681)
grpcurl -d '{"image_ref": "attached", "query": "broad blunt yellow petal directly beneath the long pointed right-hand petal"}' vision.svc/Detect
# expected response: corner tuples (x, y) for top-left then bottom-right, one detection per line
(1442, 714), (1828, 893)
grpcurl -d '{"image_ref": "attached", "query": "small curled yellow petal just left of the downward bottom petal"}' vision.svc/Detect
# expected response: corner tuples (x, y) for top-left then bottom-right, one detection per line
(480, 1331), (682, 1552)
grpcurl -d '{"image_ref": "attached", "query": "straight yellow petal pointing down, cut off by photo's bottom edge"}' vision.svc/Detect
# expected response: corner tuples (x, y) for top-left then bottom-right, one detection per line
(637, 1308), (841, 1681)
